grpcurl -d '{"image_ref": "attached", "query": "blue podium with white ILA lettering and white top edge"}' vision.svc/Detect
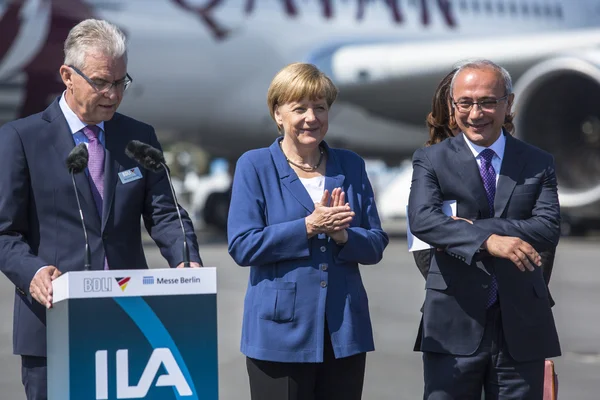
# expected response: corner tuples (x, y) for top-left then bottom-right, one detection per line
(46, 268), (218, 400)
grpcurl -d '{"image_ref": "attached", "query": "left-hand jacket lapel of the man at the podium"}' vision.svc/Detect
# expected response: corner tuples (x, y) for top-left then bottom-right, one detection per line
(41, 100), (100, 228)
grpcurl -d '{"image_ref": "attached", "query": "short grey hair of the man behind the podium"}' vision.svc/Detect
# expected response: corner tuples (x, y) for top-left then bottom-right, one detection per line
(64, 19), (127, 69)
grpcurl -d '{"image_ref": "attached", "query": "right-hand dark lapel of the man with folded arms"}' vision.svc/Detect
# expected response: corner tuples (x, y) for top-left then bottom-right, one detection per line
(494, 135), (525, 218)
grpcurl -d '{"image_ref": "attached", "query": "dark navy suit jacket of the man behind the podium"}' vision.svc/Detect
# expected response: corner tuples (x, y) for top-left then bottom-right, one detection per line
(0, 99), (200, 356)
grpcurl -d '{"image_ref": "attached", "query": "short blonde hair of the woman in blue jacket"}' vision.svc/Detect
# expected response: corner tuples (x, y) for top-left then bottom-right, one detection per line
(267, 62), (338, 131)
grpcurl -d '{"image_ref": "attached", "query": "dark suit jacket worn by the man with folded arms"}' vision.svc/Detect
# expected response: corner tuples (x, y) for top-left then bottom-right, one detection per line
(408, 135), (560, 361)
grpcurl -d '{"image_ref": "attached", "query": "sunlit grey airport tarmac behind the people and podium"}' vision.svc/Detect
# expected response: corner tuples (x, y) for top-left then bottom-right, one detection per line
(0, 233), (600, 400)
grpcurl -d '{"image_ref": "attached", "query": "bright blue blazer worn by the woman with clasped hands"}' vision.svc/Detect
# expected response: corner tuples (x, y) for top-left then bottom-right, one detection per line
(228, 138), (388, 362)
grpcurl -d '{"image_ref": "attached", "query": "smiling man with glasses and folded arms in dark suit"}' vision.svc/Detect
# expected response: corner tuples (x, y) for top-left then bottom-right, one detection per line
(408, 60), (561, 400)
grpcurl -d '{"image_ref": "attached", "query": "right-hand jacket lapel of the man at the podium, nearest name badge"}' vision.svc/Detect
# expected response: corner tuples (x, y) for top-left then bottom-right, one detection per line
(102, 114), (120, 231)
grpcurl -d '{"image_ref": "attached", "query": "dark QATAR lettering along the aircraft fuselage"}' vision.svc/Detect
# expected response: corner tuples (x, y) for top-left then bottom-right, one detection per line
(172, 0), (456, 40)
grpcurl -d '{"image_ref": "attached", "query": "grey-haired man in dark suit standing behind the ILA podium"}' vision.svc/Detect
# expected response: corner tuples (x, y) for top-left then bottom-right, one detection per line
(0, 20), (201, 400)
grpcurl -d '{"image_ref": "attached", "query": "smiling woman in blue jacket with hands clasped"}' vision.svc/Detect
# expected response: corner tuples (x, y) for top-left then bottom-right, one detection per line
(228, 63), (388, 400)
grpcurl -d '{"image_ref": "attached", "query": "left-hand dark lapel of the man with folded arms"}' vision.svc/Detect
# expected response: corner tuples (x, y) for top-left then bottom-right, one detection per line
(449, 134), (490, 215)
